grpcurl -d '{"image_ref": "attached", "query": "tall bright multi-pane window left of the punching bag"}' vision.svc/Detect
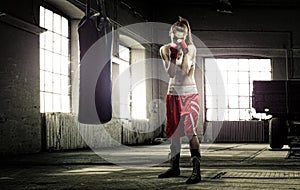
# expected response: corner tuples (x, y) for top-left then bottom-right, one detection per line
(40, 7), (70, 113)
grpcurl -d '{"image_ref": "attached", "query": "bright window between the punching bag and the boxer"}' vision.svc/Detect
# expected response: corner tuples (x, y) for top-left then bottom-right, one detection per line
(112, 45), (147, 119)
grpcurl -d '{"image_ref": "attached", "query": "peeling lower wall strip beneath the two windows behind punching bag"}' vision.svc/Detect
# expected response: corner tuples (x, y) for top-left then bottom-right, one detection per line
(45, 113), (161, 151)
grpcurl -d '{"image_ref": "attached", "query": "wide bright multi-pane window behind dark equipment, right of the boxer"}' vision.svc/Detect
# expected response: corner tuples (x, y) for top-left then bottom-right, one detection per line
(205, 58), (272, 121)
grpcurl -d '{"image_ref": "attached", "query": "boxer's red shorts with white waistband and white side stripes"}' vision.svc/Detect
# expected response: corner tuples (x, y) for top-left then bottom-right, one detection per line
(166, 85), (200, 138)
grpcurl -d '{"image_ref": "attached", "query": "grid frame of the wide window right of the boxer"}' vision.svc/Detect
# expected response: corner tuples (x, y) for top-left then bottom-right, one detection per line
(203, 57), (273, 121)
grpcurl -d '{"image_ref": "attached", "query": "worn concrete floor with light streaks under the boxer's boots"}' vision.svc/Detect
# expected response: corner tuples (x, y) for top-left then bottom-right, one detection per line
(0, 144), (300, 190)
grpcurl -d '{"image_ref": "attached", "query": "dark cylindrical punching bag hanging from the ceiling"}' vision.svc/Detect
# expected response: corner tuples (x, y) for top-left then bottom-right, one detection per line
(78, 0), (113, 124)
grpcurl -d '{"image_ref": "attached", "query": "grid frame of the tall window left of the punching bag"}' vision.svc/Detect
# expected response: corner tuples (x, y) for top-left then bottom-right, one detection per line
(39, 3), (72, 113)
